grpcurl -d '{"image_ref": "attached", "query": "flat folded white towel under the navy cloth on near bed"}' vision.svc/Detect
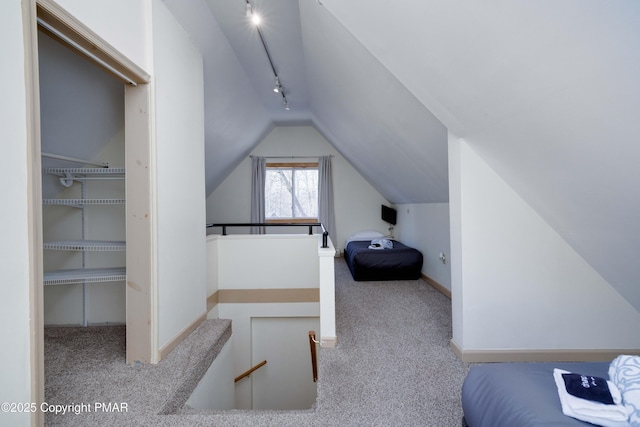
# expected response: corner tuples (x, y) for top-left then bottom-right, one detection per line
(553, 368), (629, 427)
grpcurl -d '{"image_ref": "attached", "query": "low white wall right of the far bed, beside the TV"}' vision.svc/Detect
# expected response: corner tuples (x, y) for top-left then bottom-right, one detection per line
(394, 203), (451, 290)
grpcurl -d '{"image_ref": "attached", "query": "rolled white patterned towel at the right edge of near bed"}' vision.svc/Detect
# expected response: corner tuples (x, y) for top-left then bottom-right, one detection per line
(609, 354), (640, 427)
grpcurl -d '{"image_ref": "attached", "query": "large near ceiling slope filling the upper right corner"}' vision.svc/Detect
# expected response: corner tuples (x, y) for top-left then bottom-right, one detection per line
(316, 0), (640, 309)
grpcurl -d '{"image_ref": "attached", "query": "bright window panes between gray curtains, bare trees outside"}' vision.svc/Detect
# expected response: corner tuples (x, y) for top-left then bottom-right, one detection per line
(264, 163), (318, 222)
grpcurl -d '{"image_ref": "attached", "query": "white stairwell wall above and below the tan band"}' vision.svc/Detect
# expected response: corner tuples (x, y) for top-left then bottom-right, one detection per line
(207, 234), (320, 409)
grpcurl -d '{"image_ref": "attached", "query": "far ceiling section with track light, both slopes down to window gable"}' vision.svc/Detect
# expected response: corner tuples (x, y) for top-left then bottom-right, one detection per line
(165, 0), (448, 203)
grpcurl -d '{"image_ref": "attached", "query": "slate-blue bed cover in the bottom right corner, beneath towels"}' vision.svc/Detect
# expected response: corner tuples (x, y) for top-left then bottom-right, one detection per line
(462, 362), (609, 427)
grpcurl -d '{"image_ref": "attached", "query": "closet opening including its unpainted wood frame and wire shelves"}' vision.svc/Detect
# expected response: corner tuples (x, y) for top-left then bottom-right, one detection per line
(25, 0), (158, 416)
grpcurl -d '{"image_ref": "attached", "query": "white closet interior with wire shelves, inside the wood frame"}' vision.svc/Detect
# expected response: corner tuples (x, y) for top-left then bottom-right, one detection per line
(38, 27), (126, 326)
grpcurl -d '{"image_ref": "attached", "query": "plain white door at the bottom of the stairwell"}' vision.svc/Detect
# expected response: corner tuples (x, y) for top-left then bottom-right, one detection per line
(251, 317), (320, 410)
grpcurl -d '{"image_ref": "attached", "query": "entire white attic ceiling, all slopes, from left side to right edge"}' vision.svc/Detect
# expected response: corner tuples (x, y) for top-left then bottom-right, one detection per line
(166, 0), (640, 309)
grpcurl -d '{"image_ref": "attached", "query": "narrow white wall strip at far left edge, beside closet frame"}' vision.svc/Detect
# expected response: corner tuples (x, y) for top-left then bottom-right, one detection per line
(0, 0), (31, 426)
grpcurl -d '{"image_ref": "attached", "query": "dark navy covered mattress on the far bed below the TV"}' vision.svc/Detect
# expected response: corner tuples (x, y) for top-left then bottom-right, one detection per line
(344, 240), (422, 281)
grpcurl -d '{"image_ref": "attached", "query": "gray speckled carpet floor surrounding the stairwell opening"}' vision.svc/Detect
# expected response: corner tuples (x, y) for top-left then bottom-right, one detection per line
(45, 258), (468, 427)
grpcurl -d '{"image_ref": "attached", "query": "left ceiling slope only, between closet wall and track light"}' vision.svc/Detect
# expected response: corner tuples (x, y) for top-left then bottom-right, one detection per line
(165, 0), (273, 195)
